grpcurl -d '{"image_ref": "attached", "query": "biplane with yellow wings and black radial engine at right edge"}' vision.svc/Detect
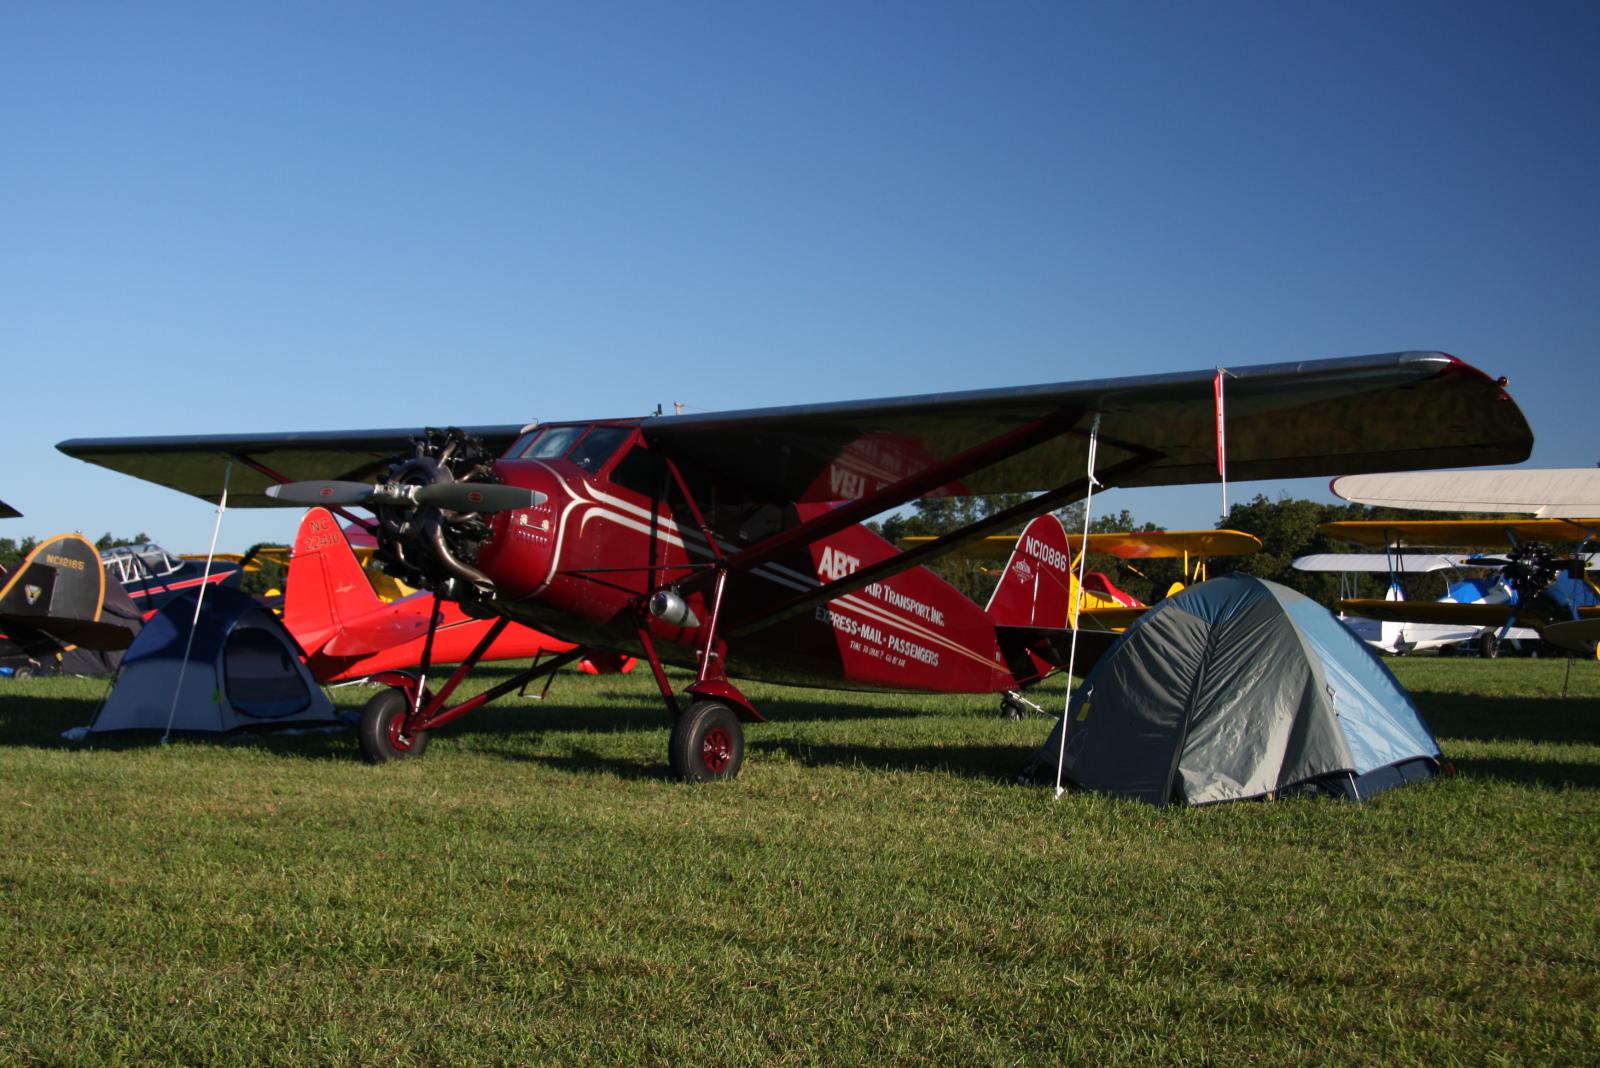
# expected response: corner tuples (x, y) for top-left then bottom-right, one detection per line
(1320, 518), (1600, 656)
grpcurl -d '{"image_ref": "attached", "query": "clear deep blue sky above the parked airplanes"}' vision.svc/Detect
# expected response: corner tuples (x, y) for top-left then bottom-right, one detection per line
(0, 2), (1600, 552)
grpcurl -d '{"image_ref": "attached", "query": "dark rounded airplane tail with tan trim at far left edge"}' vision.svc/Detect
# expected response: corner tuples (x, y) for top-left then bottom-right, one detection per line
(0, 534), (134, 674)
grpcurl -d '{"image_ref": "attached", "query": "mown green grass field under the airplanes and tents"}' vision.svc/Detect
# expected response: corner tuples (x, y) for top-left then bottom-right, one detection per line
(0, 659), (1600, 1065)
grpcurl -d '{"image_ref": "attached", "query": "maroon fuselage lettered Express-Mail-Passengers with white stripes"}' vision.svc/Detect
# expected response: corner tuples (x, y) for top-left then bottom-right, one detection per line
(477, 432), (1029, 692)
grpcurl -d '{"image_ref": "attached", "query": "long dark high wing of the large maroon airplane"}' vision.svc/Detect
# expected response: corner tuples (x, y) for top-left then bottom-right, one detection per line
(56, 352), (1533, 507)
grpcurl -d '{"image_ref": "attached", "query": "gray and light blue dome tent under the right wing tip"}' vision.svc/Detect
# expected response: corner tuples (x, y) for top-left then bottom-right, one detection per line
(1021, 574), (1440, 804)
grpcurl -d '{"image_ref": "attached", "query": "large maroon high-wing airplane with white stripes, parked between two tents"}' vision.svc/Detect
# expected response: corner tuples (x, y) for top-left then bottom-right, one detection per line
(58, 352), (1533, 780)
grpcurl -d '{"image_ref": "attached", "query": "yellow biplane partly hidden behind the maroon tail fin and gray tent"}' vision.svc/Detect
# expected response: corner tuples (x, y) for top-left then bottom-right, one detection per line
(898, 520), (1261, 630)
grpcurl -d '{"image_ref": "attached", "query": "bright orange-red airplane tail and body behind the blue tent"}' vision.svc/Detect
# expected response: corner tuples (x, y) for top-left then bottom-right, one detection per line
(283, 508), (634, 683)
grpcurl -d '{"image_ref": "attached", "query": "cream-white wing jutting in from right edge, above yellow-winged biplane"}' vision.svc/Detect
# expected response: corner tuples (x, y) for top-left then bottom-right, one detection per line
(1333, 467), (1600, 520)
